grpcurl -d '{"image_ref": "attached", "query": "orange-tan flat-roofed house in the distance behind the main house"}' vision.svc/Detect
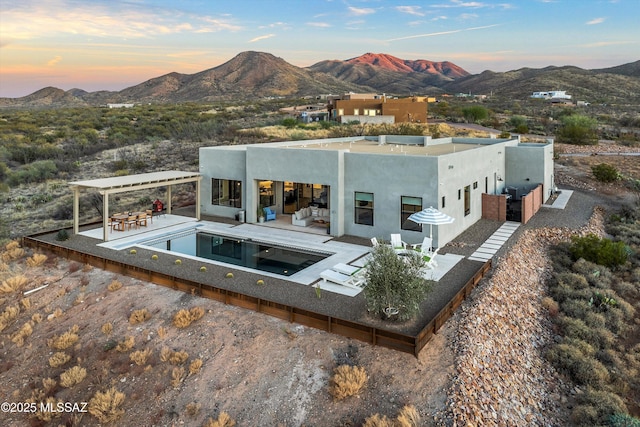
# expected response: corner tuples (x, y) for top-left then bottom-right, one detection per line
(329, 93), (427, 123)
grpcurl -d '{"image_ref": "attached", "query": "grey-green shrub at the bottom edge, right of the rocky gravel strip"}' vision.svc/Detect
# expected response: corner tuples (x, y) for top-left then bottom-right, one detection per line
(571, 389), (627, 427)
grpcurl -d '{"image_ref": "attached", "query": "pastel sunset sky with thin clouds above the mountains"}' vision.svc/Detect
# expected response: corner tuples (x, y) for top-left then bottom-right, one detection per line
(0, 0), (640, 98)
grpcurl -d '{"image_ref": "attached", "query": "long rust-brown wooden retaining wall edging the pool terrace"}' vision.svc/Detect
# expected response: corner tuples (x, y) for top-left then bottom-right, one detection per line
(22, 236), (491, 357)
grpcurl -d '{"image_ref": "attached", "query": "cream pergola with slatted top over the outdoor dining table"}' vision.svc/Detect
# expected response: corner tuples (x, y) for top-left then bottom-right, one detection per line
(69, 171), (202, 242)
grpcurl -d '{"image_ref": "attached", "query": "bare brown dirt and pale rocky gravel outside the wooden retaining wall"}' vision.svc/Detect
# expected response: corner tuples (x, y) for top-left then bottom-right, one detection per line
(0, 141), (637, 426)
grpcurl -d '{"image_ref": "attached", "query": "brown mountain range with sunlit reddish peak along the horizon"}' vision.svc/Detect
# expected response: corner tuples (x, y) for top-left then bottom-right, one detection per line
(0, 51), (640, 107)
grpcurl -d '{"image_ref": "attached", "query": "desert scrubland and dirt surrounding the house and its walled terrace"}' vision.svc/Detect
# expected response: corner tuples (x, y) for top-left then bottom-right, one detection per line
(0, 54), (640, 426)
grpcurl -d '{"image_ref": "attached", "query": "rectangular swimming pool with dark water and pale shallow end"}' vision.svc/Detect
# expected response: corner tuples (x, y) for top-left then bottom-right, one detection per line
(139, 229), (332, 276)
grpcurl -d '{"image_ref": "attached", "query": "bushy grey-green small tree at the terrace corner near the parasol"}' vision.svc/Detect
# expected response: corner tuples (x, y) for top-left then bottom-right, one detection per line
(364, 245), (433, 320)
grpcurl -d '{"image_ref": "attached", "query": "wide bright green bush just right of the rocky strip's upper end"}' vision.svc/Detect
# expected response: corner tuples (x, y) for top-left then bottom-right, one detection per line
(569, 234), (629, 267)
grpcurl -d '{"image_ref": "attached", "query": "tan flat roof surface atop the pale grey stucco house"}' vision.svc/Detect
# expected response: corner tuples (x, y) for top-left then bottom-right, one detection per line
(286, 139), (480, 156)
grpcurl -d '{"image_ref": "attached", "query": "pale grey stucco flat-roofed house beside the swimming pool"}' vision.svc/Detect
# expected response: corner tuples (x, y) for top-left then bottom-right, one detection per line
(200, 135), (554, 246)
